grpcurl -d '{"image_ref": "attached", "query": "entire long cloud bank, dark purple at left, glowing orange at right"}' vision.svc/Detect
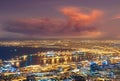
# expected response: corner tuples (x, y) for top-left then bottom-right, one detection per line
(4, 7), (101, 37)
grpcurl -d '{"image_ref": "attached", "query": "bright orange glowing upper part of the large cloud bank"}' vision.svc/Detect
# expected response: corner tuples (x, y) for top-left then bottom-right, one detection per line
(61, 7), (103, 25)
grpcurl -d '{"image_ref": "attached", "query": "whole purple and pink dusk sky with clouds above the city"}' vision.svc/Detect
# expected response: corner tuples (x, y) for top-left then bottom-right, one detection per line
(0, 0), (120, 39)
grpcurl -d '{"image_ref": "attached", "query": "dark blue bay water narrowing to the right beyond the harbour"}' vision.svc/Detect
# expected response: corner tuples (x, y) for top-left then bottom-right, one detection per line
(0, 46), (68, 60)
